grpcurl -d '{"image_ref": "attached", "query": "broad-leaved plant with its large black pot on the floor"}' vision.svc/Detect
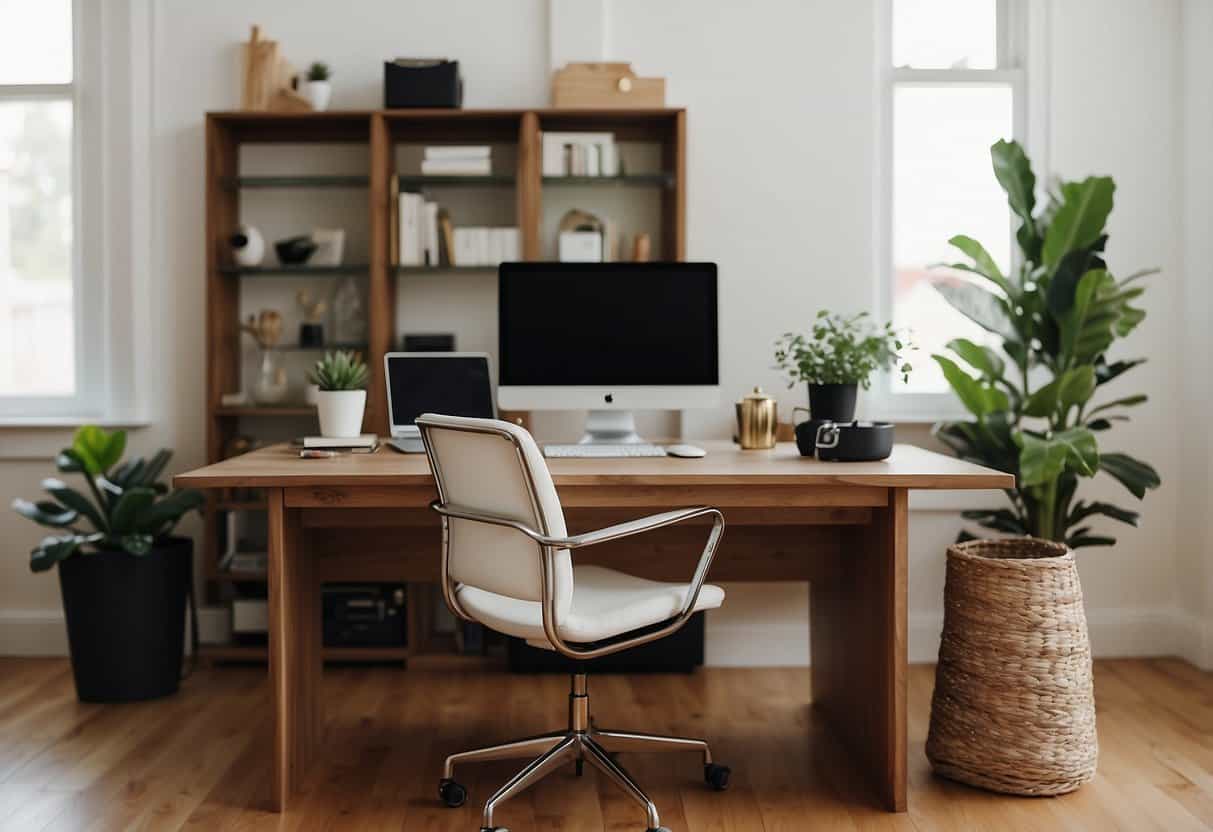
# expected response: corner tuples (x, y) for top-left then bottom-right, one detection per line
(12, 426), (203, 702)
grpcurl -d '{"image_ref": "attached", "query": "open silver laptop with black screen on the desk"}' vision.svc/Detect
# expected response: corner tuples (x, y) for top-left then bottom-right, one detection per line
(383, 353), (497, 454)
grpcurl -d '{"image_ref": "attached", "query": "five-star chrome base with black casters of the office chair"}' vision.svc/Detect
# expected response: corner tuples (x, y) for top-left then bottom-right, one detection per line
(438, 673), (729, 832)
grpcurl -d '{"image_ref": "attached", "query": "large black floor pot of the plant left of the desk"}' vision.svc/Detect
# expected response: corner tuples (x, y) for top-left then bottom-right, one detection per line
(59, 537), (194, 702)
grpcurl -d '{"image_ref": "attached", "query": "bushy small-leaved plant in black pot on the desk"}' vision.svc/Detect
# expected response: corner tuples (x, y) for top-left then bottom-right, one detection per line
(775, 309), (911, 422)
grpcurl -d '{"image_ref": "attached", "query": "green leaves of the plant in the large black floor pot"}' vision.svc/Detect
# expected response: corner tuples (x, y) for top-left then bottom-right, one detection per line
(12, 426), (203, 572)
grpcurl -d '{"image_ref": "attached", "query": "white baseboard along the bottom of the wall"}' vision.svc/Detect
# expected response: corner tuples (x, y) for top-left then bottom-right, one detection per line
(0, 608), (1213, 669)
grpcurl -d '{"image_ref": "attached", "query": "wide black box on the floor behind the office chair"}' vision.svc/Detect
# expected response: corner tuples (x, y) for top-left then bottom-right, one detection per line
(508, 612), (704, 673)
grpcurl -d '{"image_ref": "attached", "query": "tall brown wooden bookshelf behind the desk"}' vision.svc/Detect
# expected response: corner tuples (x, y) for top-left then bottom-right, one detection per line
(201, 109), (687, 668)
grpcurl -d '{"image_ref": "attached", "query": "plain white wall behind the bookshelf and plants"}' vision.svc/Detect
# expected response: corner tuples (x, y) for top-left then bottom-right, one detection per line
(0, 0), (1198, 663)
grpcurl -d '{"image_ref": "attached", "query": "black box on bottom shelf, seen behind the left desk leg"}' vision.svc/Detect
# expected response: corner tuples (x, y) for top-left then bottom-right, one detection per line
(321, 583), (406, 648)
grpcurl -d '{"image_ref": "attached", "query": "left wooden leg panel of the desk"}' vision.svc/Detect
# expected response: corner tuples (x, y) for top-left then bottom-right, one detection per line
(266, 489), (321, 811)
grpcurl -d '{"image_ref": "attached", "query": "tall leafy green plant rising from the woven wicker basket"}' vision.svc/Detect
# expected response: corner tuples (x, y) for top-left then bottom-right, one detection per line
(934, 141), (1160, 548)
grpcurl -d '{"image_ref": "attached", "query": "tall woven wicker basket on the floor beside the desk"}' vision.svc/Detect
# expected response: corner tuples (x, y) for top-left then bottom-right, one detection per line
(927, 537), (1099, 794)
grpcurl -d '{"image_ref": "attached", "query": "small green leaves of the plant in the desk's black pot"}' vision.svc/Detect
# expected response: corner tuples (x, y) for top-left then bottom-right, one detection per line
(775, 309), (913, 389)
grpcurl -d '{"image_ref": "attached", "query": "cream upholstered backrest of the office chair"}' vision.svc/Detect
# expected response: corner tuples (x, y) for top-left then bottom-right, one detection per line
(417, 414), (573, 614)
